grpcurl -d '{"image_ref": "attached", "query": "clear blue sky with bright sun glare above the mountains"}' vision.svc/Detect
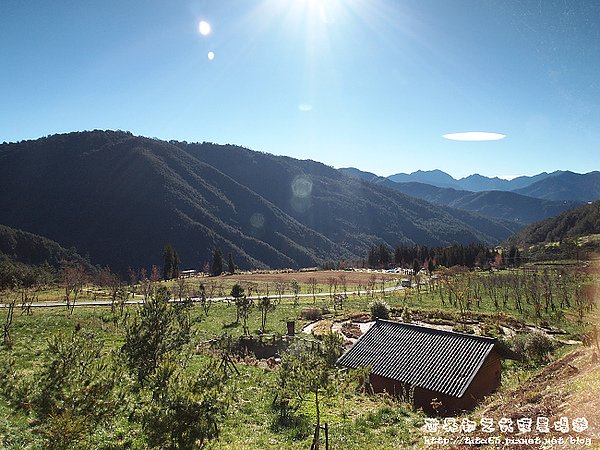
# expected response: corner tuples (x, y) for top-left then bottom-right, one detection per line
(0, 0), (600, 177)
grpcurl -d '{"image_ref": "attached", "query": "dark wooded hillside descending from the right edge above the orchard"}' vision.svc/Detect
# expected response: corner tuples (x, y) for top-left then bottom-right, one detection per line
(509, 201), (600, 245)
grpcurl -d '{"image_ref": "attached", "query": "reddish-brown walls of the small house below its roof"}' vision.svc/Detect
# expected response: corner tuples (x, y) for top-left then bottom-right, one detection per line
(370, 350), (502, 415)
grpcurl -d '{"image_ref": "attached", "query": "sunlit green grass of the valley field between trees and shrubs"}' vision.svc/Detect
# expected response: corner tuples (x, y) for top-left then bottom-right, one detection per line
(0, 272), (593, 449)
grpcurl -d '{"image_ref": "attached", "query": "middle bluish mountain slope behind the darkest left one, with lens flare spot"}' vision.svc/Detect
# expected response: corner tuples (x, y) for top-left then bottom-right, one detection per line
(180, 143), (510, 250)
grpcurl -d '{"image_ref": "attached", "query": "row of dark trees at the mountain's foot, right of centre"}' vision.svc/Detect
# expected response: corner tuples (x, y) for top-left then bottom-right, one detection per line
(366, 244), (521, 270)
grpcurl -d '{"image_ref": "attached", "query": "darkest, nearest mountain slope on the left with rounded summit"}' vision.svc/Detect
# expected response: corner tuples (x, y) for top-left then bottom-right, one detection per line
(0, 132), (348, 270)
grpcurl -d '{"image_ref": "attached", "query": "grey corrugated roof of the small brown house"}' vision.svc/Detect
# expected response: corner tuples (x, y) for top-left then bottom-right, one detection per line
(337, 319), (496, 397)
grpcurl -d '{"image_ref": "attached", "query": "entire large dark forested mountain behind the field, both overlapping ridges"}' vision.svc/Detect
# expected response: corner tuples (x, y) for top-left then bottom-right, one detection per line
(0, 131), (511, 271)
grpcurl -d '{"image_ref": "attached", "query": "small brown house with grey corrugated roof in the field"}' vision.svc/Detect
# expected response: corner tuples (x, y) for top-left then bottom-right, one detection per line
(337, 319), (516, 415)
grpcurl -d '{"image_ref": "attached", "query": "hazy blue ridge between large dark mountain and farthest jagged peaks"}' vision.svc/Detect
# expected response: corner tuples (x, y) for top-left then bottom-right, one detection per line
(339, 168), (581, 225)
